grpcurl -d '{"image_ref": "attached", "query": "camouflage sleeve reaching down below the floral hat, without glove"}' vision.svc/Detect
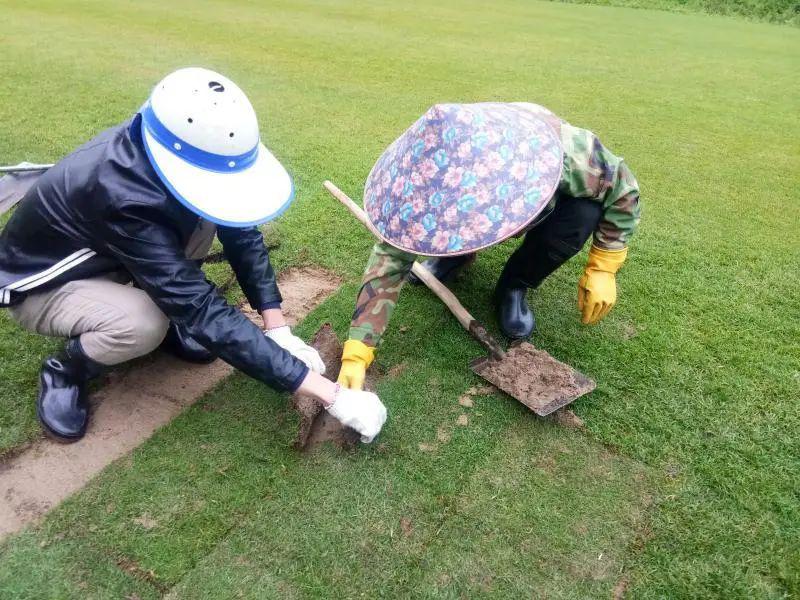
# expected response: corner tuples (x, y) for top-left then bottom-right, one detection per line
(349, 242), (416, 347)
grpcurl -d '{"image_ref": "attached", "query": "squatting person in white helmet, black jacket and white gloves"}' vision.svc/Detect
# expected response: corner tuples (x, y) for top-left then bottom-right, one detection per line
(0, 68), (386, 442)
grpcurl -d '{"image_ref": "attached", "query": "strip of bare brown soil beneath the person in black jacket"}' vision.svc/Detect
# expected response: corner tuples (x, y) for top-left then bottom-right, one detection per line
(0, 268), (341, 540)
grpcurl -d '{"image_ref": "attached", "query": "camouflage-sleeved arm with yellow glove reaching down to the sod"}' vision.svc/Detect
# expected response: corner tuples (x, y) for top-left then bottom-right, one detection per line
(338, 242), (416, 389)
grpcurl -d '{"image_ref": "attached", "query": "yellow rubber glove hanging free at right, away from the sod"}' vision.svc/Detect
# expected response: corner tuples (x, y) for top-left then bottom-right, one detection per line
(578, 246), (628, 325)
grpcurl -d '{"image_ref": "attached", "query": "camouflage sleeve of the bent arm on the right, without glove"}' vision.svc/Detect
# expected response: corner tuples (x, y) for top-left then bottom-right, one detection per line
(559, 123), (640, 250)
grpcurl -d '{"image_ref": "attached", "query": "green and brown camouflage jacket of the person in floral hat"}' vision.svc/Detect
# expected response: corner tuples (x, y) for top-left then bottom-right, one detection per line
(349, 105), (639, 347)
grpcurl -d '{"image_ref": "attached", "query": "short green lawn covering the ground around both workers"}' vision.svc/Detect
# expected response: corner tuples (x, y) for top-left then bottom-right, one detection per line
(0, 1), (800, 598)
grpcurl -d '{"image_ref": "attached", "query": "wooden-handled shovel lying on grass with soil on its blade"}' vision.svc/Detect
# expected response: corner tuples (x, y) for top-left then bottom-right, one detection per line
(324, 181), (596, 417)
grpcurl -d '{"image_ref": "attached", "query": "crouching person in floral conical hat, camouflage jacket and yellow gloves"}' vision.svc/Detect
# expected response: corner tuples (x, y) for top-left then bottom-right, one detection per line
(339, 103), (639, 389)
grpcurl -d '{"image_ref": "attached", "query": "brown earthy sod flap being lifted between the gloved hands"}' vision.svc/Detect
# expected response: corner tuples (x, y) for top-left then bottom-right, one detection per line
(292, 323), (359, 450)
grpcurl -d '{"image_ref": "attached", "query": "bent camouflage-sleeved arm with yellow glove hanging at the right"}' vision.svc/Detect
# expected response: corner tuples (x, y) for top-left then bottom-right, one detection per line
(559, 125), (640, 324)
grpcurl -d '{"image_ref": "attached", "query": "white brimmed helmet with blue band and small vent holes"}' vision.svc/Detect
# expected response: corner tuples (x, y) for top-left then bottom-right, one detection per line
(140, 67), (294, 227)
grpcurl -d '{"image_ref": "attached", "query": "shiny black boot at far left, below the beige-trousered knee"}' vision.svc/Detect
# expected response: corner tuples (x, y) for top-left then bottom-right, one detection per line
(36, 338), (104, 443)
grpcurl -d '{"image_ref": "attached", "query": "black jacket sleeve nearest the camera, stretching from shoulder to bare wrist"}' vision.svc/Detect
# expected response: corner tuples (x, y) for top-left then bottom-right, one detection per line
(97, 201), (309, 392)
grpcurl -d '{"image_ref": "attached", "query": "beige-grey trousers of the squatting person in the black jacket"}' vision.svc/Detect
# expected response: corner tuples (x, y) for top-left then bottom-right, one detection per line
(9, 221), (216, 365)
